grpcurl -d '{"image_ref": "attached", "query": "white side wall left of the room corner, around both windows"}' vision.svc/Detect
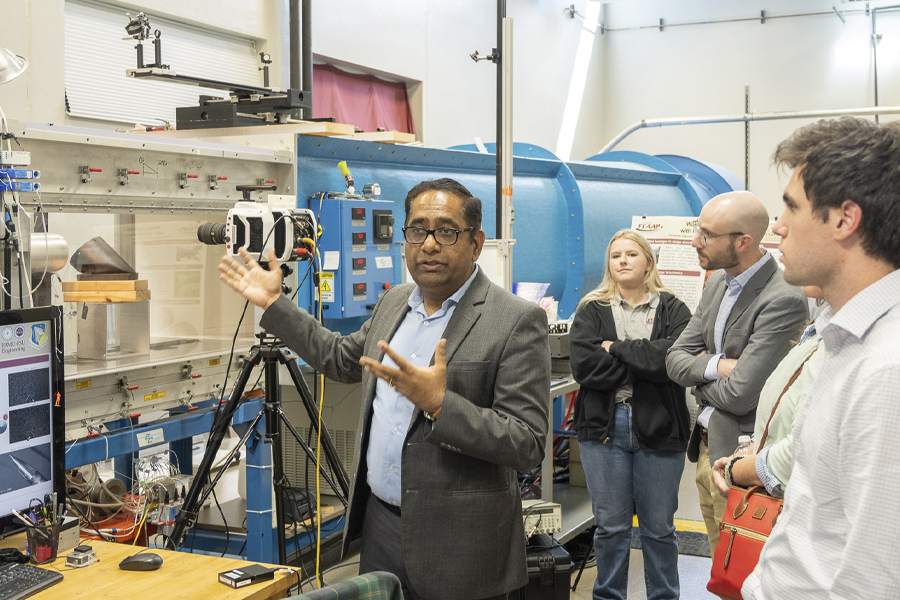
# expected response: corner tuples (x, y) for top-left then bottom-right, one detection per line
(0, 0), (603, 155)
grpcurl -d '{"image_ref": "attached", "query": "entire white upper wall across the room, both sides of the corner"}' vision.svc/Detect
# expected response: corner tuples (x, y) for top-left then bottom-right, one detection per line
(8, 0), (900, 214)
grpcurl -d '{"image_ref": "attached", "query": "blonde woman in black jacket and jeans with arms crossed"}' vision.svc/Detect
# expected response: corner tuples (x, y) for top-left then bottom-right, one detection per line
(570, 230), (691, 600)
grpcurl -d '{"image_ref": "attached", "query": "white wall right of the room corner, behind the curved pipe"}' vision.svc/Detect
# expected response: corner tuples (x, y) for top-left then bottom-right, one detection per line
(597, 0), (900, 215)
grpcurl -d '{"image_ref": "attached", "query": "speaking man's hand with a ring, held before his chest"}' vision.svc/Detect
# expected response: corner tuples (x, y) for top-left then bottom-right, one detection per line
(359, 340), (447, 414)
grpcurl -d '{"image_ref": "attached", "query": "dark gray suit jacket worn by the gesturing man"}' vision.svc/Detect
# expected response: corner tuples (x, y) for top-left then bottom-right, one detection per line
(260, 271), (550, 600)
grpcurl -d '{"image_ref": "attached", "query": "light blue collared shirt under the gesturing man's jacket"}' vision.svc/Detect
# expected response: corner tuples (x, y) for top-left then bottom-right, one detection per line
(366, 265), (478, 506)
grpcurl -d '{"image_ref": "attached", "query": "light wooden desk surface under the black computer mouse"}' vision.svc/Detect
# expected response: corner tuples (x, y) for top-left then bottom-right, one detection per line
(18, 540), (297, 600)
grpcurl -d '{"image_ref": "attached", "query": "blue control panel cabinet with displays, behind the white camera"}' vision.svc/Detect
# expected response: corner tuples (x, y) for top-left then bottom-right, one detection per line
(310, 198), (395, 319)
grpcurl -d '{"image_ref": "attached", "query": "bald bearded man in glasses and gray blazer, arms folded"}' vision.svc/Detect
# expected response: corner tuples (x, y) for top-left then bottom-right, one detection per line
(666, 192), (808, 554)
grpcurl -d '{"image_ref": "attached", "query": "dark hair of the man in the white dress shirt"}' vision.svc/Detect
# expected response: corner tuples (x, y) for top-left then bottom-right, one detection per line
(772, 117), (900, 268)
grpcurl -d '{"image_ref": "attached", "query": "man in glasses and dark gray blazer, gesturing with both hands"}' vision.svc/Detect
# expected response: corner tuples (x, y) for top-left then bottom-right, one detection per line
(219, 179), (550, 600)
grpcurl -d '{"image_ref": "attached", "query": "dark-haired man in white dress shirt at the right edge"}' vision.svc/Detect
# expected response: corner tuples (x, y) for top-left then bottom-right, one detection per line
(742, 118), (900, 600)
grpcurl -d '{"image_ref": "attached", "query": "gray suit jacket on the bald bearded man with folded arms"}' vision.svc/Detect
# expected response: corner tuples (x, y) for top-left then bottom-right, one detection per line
(666, 259), (809, 464)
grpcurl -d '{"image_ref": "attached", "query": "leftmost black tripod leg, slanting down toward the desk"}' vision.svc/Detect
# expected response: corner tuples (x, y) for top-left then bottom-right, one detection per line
(167, 347), (261, 550)
